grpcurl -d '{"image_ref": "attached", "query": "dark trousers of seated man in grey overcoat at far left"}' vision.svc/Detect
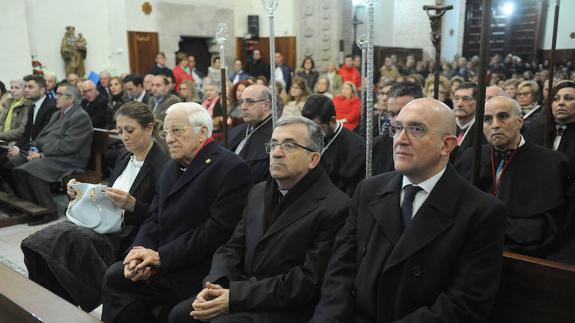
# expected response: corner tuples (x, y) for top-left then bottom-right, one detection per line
(12, 168), (58, 213)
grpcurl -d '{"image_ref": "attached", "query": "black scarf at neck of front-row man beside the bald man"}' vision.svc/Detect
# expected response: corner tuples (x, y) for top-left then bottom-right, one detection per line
(264, 167), (323, 230)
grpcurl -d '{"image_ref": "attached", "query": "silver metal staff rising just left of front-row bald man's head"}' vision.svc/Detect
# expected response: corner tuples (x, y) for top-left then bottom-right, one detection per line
(362, 0), (376, 177)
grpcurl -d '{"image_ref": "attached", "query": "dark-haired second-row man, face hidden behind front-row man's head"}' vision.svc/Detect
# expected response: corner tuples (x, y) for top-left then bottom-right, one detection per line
(301, 94), (365, 196)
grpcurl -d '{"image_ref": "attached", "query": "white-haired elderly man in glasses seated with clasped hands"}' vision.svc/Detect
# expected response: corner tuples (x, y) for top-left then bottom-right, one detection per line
(102, 102), (251, 323)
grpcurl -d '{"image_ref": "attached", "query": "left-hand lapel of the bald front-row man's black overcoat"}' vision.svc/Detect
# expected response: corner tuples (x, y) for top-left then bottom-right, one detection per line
(369, 173), (402, 245)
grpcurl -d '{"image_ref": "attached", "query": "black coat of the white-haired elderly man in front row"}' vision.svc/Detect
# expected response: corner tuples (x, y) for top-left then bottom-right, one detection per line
(133, 142), (251, 295)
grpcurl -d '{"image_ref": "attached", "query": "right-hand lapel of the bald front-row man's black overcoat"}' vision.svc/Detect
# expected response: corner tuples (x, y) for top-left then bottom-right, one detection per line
(383, 166), (460, 272)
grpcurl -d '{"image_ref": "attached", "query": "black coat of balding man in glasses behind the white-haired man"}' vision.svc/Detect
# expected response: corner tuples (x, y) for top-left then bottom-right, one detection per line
(229, 117), (273, 183)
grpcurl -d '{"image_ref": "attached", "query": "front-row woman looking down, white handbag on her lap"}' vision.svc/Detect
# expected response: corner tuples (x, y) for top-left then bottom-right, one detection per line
(21, 102), (169, 312)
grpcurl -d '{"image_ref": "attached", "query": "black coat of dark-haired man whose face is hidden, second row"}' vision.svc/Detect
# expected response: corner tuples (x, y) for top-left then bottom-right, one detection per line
(320, 127), (365, 196)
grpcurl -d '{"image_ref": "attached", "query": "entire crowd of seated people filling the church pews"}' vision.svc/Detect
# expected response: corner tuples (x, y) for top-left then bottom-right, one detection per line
(0, 50), (575, 322)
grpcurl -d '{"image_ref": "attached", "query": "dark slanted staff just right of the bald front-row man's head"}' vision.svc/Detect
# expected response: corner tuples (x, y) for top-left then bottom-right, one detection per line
(472, 0), (491, 187)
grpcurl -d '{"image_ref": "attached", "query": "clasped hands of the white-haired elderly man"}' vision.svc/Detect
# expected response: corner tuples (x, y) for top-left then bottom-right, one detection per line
(123, 246), (161, 282)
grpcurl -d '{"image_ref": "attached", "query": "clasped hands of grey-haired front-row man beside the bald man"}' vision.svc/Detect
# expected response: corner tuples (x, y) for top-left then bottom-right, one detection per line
(190, 282), (230, 321)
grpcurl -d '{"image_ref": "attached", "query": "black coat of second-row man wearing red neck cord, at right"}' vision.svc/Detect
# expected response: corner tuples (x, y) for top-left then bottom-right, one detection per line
(456, 142), (572, 257)
